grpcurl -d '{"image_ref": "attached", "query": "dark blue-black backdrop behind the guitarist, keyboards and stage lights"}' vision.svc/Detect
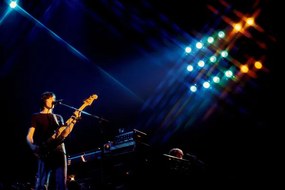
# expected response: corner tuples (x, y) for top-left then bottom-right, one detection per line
(0, 0), (283, 187)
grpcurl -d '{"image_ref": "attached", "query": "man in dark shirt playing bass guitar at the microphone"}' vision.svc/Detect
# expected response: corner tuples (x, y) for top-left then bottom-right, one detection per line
(26, 91), (97, 190)
